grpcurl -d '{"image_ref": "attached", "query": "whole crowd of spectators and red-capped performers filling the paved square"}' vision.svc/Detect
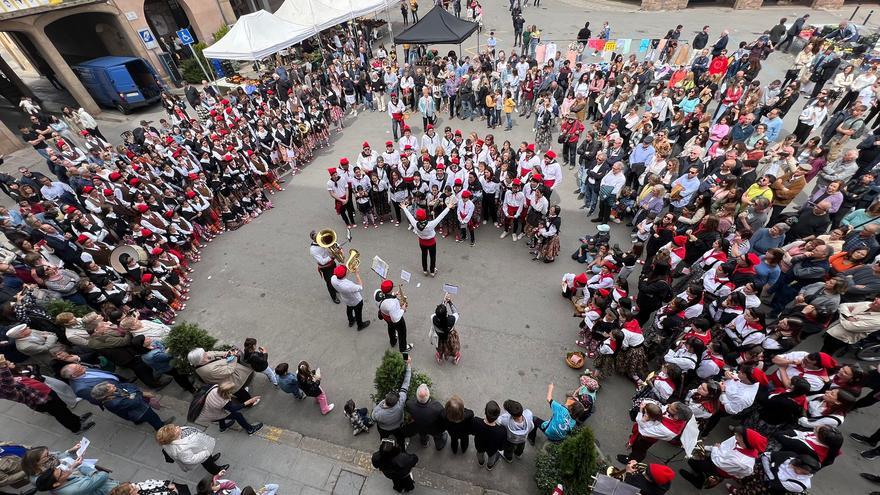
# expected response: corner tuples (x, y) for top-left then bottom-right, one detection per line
(0, 1), (880, 495)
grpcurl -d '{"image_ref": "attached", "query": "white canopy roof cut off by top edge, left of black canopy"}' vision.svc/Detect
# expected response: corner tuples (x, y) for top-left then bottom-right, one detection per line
(275, 0), (386, 33)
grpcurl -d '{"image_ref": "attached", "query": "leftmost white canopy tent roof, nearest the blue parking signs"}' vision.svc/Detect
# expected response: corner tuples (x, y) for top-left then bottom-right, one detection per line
(202, 10), (314, 60)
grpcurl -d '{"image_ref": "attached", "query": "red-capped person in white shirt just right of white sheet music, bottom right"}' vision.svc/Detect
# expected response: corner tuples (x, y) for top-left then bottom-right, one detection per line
(678, 426), (767, 490)
